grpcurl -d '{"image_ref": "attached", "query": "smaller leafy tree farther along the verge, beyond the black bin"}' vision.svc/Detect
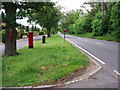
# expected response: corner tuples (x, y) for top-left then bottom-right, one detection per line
(28, 3), (61, 37)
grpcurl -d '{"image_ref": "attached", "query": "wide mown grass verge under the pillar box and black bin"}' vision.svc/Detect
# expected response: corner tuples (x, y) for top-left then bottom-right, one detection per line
(2, 35), (89, 86)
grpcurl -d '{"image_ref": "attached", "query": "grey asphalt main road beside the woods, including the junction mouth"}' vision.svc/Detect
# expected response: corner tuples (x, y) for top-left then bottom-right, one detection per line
(58, 32), (120, 88)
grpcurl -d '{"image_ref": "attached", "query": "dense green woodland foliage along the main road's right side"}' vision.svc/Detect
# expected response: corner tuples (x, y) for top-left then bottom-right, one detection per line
(59, 1), (120, 42)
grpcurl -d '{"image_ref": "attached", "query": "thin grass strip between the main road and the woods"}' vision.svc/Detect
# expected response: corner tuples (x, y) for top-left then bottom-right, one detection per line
(71, 33), (120, 42)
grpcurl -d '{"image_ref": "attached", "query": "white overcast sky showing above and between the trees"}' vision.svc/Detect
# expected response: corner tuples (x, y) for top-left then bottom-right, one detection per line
(17, 0), (88, 28)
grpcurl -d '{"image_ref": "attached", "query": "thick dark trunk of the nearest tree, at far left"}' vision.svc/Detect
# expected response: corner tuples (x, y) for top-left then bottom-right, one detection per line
(4, 2), (17, 56)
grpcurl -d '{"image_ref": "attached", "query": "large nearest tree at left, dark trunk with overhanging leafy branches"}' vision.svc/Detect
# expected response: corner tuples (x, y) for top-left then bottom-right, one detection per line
(2, 2), (58, 56)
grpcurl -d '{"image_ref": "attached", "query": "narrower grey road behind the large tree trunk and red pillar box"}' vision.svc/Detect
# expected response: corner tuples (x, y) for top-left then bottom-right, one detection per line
(0, 36), (41, 56)
